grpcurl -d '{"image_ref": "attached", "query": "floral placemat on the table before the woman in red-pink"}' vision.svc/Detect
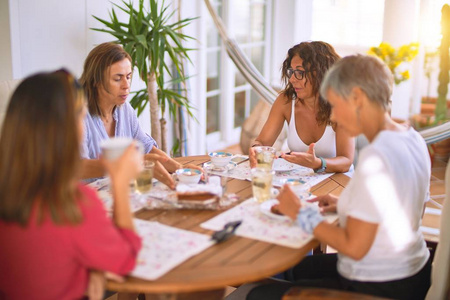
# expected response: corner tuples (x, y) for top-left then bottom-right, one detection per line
(131, 219), (214, 280)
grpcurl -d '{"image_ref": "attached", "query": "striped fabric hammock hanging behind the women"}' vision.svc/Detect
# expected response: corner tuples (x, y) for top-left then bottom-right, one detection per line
(205, 0), (450, 144)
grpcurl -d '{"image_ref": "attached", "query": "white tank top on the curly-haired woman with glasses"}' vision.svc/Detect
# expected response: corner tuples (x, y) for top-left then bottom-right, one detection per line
(288, 99), (336, 158)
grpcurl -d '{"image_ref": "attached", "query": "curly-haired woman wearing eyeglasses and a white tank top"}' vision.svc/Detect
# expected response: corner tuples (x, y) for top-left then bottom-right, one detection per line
(249, 41), (355, 172)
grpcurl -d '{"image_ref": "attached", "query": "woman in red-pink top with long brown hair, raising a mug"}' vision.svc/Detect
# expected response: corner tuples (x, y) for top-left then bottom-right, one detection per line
(0, 70), (141, 300)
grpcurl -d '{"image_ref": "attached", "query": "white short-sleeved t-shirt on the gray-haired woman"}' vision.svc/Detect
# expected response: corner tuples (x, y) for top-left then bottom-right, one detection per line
(337, 128), (431, 282)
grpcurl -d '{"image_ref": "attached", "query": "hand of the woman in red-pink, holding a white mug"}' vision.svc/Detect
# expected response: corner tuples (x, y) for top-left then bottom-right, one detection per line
(101, 142), (143, 185)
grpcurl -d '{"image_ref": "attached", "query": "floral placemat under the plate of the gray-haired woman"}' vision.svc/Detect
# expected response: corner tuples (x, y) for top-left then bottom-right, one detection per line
(200, 198), (337, 248)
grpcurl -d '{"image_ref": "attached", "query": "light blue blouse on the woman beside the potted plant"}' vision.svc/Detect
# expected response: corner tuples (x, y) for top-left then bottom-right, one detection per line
(81, 102), (158, 159)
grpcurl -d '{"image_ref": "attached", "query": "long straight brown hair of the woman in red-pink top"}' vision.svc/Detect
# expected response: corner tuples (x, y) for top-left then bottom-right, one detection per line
(0, 70), (85, 226)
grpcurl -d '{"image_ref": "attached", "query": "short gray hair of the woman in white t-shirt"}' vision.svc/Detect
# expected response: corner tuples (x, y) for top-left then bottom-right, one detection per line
(320, 54), (394, 111)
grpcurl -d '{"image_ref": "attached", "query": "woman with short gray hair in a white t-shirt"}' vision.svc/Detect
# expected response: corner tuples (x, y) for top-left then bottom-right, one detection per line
(247, 55), (431, 299)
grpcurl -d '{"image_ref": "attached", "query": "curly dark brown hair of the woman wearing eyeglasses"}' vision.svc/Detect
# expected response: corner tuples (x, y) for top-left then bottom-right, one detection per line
(281, 41), (340, 124)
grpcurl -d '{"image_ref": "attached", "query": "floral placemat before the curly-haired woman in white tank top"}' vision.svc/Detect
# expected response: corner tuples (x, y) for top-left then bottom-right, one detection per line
(209, 161), (334, 187)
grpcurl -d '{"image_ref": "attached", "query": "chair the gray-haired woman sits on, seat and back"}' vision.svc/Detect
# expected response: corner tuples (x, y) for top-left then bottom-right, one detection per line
(283, 163), (450, 300)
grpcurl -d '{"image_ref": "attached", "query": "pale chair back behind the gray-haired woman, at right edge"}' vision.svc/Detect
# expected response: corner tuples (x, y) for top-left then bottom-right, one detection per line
(426, 163), (450, 300)
